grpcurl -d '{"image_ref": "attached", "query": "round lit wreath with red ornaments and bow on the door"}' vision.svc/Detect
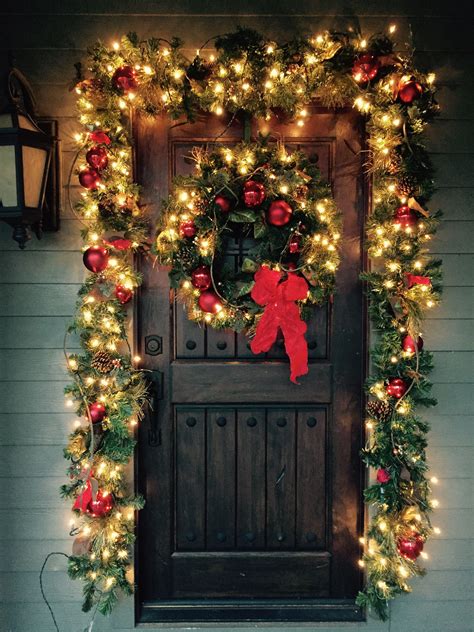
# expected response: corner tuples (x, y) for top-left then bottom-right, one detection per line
(156, 142), (341, 381)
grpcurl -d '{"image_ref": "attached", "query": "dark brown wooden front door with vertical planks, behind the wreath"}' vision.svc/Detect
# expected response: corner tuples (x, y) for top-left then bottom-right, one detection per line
(136, 108), (364, 621)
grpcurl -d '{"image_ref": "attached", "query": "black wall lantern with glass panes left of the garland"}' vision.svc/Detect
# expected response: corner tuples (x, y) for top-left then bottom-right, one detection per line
(0, 68), (56, 249)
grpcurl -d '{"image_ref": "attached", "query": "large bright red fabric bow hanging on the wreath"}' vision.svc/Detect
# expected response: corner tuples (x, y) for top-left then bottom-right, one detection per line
(250, 266), (308, 384)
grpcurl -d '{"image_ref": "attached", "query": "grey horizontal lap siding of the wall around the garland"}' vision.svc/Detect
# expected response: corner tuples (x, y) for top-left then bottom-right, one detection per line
(0, 0), (474, 632)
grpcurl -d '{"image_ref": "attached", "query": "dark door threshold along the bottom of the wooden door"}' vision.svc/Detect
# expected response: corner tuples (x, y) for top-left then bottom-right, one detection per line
(137, 599), (364, 624)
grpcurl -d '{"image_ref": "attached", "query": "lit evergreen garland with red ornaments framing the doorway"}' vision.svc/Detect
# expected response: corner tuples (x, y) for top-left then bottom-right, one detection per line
(63, 27), (439, 618)
